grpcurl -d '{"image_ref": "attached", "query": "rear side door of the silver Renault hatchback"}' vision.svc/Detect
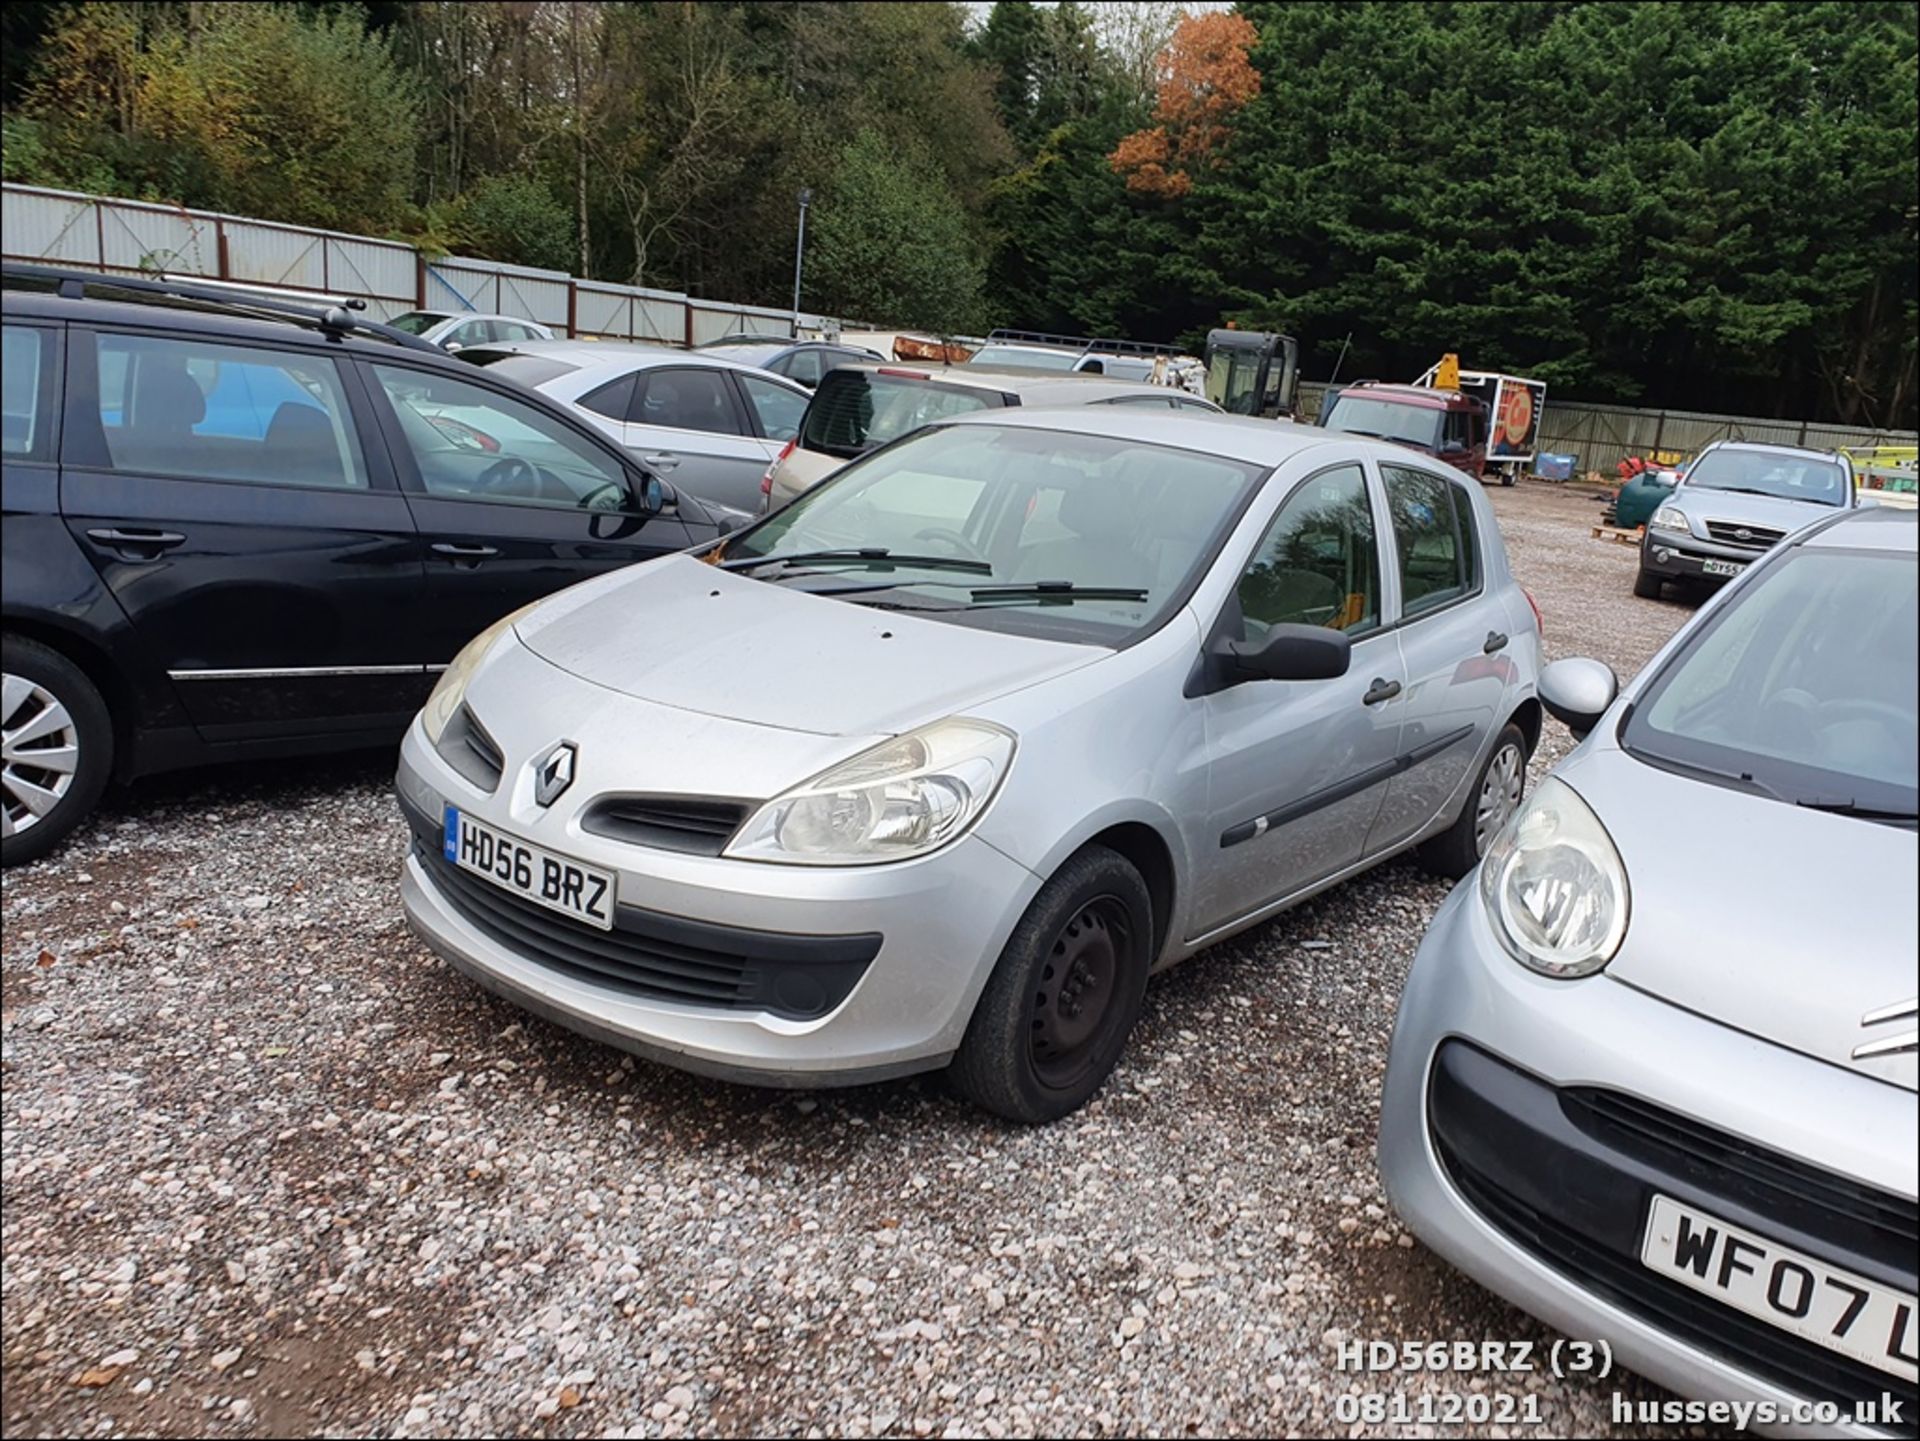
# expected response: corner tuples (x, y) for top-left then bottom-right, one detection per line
(1367, 462), (1517, 852)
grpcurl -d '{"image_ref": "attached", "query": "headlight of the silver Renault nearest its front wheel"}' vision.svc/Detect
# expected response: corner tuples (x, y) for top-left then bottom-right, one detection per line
(726, 720), (1014, 865)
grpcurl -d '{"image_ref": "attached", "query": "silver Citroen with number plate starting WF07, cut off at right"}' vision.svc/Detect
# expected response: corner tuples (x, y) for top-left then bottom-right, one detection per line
(1380, 508), (1920, 1435)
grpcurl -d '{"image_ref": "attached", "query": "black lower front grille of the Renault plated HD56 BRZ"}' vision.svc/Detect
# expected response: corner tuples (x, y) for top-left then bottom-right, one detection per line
(401, 821), (881, 1021)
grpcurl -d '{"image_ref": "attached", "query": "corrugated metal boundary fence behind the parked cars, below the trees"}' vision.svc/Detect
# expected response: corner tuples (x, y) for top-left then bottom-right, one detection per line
(0, 184), (1916, 462)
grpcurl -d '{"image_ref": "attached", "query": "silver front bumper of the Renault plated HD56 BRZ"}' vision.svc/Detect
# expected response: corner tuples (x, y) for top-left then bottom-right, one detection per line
(396, 723), (1041, 1086)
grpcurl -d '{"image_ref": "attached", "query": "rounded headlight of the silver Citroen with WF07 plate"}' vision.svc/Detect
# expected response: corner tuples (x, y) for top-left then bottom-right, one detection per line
(1480, 777), (1628, 979)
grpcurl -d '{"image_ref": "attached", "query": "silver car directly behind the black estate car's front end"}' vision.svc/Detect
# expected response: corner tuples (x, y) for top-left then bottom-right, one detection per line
(461, 340), (812, 516)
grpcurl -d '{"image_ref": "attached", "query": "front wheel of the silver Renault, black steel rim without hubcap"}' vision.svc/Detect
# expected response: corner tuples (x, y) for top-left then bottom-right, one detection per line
(948, 846), (1154, 1124)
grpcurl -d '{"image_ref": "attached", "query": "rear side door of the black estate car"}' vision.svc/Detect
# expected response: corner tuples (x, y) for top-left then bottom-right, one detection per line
(61, 326), (426, 741)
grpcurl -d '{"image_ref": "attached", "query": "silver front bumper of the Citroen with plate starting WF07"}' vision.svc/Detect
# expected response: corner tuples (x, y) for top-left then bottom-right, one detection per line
(1380, 881), (1920, 1435)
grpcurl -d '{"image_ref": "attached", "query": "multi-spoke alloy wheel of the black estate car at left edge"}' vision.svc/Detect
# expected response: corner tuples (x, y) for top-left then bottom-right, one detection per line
(0, 635), (113, 865)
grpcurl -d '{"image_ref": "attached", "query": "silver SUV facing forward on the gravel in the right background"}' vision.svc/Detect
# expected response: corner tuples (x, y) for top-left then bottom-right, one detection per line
(1634, 439), (1860, 601)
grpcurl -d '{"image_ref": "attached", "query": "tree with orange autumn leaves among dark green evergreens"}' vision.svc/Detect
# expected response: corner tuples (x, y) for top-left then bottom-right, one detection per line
(1108, 12), (1260, 198)
